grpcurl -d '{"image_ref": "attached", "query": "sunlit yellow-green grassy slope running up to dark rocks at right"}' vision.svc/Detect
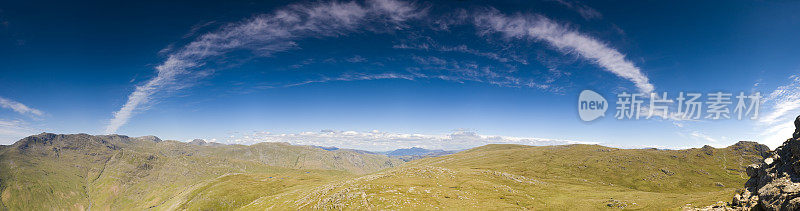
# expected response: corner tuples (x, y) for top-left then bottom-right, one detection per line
(250, 143), (765, 210)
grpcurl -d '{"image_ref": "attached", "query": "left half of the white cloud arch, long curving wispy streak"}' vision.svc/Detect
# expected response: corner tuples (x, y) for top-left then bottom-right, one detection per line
(111, 0), (426, 133)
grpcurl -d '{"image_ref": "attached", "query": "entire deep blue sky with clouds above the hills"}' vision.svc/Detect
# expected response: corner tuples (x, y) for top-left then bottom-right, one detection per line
(0, 0), (800, 150)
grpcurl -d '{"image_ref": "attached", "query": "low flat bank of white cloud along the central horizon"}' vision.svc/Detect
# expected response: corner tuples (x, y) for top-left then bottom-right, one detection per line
(219, 130), (596, 151)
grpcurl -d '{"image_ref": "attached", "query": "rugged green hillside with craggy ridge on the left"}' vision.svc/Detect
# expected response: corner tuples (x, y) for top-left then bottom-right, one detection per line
(0, 134), (402, 210)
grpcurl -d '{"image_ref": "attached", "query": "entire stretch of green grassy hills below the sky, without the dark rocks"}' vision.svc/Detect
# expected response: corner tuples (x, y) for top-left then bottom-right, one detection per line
(0, 133), (768, 210)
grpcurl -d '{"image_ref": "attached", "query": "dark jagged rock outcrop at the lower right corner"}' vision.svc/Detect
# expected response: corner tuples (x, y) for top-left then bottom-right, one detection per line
(731, 116), (800, 210)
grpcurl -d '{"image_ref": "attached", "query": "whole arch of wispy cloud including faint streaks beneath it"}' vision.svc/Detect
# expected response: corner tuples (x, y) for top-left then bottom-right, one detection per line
(105, 0), (654, 133)
